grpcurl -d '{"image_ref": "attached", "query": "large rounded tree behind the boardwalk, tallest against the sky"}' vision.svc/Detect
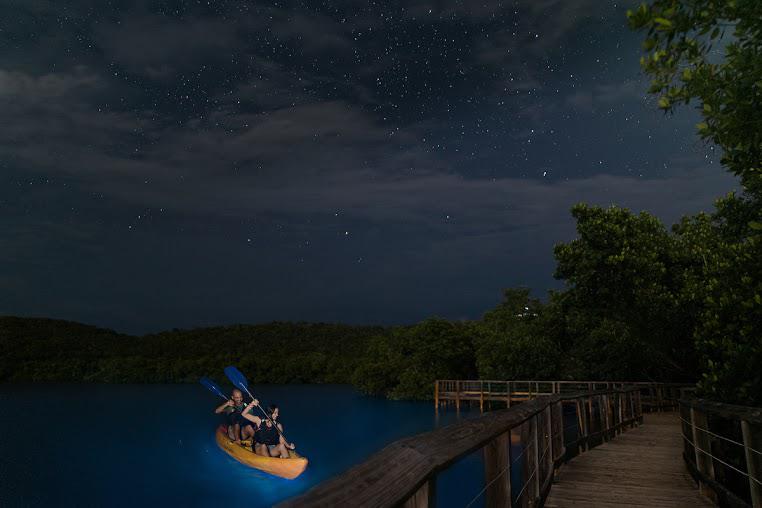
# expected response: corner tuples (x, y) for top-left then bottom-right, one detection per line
(555, 204), (695, 381)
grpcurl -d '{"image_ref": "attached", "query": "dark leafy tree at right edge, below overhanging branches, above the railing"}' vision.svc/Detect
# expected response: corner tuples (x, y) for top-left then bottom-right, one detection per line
(675, 194), (762, 405)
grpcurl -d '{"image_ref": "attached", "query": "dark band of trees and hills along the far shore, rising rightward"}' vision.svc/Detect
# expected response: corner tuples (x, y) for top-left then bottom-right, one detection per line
(0, 195), (762, 405)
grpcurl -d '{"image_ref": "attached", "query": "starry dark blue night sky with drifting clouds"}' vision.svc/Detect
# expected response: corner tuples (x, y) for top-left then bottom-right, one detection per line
(0, 0), (738, 333)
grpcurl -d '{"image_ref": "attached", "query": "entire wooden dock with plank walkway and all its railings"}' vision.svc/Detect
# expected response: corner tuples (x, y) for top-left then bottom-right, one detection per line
(277, 380), (762, 508)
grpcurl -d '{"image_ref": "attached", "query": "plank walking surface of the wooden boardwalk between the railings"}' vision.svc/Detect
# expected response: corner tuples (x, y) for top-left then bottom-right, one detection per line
(545, 413), (714, 508)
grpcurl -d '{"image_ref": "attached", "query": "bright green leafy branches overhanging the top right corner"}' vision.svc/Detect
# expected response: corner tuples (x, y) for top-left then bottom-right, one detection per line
(627, 0), (762, 194)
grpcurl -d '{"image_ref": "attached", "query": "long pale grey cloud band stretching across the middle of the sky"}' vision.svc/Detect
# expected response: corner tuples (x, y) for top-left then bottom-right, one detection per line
(0, 60), (734, 243)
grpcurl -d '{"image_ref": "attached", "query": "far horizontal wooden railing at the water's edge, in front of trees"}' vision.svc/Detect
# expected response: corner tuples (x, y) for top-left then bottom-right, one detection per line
(434, 379), (693, 411)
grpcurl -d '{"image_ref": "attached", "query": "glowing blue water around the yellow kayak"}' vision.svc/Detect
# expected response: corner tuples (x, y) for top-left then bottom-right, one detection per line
(0, 385), (504, 508)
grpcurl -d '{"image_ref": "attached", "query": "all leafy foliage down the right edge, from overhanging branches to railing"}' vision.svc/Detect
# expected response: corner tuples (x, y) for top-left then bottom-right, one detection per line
(627, 0), (762, 405)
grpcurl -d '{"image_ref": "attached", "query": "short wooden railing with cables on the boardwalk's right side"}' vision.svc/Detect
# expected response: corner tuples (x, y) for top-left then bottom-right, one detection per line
(680, 399), (762, 508)
